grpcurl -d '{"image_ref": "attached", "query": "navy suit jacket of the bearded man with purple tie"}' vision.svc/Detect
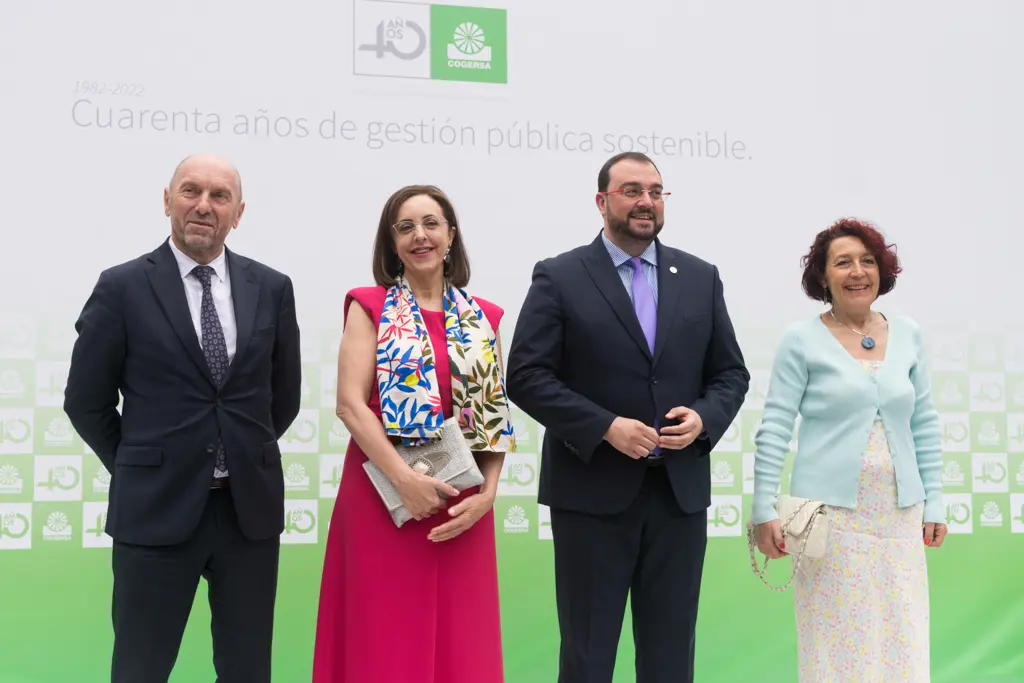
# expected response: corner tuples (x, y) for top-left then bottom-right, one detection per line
(507, 236), (750, 514)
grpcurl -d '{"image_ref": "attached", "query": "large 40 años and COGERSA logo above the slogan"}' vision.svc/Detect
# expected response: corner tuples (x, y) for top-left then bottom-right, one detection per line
(352, 0), (508, 83)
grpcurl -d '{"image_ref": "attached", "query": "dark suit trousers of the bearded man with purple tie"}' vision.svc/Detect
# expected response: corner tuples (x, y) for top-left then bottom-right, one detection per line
(551, 464), (708, 683)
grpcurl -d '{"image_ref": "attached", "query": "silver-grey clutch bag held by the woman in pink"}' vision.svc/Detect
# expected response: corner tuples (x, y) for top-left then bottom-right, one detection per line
(362, 418), (483, 527)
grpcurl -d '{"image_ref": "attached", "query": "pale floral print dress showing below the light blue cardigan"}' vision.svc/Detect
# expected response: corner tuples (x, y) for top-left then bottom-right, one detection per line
(793, 413), (930, 683)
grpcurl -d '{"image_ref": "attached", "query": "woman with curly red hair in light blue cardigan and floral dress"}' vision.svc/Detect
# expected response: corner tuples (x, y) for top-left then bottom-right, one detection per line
(752, 220), (946, 683)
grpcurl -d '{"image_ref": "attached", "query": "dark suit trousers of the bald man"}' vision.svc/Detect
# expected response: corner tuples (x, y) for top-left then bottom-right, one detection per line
(111, 488), (281, 683)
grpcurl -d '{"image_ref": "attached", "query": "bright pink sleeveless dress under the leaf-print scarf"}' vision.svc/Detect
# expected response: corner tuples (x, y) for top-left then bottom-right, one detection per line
(312, 287), (504, 683)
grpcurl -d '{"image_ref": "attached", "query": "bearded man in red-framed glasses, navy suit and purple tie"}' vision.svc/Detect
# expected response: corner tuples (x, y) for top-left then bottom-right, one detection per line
(507, 153), (750, 683)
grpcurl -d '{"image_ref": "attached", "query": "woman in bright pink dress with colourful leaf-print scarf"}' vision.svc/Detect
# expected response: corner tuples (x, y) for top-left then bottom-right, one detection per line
(313, 185), (514, 683)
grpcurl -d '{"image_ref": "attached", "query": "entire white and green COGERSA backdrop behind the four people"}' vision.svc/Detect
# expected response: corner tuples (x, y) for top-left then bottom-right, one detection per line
(0, 0), (1024, 683)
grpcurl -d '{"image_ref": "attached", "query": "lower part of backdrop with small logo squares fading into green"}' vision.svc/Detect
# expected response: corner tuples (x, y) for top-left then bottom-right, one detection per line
(0, 315), (1024, 683)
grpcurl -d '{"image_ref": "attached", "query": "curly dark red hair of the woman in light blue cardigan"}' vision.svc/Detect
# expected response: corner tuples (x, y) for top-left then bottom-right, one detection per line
(801, 218), (903, 303)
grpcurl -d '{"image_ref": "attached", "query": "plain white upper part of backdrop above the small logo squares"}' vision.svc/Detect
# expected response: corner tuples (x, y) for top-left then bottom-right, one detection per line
(0, 0), (1024, 360)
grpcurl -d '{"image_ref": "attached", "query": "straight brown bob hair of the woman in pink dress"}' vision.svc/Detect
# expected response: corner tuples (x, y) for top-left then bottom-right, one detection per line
(374, 185), (469, 288)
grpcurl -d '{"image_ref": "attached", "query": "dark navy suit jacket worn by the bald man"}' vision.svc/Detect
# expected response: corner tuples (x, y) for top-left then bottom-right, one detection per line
(63, 242), (302, 545)
